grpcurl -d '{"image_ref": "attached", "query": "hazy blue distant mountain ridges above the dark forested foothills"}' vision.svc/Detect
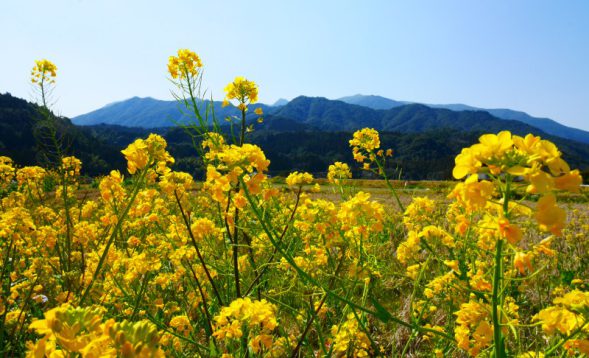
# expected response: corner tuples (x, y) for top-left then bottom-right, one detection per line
(72, 95), (589, 143)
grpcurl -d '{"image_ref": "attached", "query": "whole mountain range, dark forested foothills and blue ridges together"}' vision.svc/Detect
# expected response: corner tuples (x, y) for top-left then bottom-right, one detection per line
(0, 94), (589, 180)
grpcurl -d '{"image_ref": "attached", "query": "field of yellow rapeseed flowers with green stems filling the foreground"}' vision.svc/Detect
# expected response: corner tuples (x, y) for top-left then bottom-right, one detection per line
(0, 50), (589, 357)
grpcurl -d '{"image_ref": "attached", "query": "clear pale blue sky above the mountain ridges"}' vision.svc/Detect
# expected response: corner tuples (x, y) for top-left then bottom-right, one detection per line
(0, 0), (589, 130)
